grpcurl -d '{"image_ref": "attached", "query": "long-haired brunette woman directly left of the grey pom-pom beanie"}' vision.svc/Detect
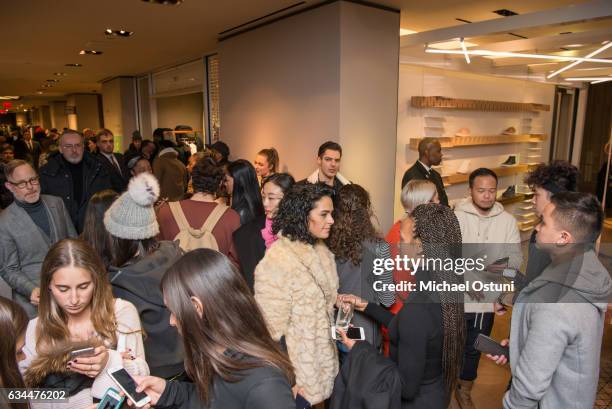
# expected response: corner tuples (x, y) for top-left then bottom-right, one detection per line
(81, 189), (119, 269)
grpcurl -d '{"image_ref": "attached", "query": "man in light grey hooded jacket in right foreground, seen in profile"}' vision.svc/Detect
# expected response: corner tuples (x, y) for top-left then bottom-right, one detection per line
(489, 192), (612, 409)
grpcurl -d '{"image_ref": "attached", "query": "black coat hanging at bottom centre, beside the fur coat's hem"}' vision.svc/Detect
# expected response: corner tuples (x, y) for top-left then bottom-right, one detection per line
(331, 342), (402, 409)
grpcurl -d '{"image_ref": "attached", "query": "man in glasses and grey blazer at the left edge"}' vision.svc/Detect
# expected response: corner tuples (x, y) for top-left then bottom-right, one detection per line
(0, 159), (77, 317)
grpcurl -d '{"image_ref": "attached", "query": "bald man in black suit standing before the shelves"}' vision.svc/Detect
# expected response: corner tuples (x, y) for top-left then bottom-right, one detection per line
(402, 138), (448, 206)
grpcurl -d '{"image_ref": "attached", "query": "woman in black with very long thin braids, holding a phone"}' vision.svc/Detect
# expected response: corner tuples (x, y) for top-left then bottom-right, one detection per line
(338, 204), (465, 409)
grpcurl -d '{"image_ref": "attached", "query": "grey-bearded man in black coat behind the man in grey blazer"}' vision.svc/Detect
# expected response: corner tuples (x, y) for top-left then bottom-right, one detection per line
(40, 129), (114, 232)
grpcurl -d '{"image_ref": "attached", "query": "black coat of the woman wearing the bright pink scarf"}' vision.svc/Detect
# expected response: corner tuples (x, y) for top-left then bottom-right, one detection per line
(233, 216), (266, 291)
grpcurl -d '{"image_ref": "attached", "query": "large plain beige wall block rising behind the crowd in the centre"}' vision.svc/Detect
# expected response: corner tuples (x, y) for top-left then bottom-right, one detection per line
(219, 2), (399, 229)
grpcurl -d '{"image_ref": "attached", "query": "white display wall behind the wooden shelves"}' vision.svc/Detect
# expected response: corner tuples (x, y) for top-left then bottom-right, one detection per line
(395, 64), (554, 219)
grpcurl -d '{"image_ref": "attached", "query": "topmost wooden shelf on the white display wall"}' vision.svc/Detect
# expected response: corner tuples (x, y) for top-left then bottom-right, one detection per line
(410, 96), (550, 112)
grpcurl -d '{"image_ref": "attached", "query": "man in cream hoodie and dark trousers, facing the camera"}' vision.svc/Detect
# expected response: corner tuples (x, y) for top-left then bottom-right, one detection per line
(455, 168), (523, 409)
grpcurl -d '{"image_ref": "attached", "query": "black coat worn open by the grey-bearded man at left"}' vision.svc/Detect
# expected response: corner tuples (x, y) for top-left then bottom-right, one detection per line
(39, 152), (113, 233)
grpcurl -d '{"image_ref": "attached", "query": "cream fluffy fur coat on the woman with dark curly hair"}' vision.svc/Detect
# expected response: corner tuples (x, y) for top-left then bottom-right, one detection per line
(255, 236), (338, 404)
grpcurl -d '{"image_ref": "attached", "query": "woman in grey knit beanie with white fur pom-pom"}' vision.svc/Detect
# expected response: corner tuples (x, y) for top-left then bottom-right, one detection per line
(104, 173), (184, 378)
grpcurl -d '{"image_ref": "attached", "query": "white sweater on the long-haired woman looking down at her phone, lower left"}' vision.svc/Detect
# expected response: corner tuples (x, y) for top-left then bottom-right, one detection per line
(19, 298), (149, 409)
